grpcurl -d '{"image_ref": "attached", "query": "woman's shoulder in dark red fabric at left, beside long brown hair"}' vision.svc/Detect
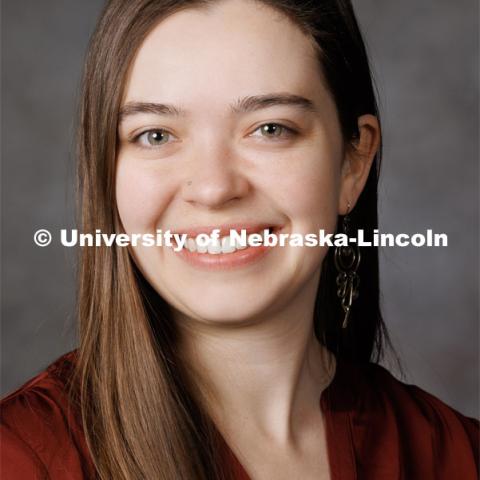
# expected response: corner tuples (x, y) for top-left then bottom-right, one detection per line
(0, 352), (94, 479)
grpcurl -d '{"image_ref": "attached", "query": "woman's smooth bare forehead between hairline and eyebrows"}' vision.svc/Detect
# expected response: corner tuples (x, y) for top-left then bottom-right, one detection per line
(124, 0), (322, 107)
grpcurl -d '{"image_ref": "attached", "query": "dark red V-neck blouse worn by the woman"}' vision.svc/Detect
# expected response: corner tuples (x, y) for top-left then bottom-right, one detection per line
(0, 353), (479, 480)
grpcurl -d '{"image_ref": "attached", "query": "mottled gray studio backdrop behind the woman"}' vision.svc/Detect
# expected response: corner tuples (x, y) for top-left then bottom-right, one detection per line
(1, 0), (479, 416)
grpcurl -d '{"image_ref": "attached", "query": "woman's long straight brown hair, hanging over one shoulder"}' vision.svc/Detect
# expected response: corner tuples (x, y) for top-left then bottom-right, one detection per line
(75, 0), (384, 480)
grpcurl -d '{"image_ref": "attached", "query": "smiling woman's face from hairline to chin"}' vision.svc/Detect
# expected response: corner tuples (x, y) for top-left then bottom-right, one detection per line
(116, 0), (344, 322)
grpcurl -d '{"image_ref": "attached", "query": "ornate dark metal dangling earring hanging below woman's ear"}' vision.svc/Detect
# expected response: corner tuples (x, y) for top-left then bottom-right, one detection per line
(335, 203), (360, 328)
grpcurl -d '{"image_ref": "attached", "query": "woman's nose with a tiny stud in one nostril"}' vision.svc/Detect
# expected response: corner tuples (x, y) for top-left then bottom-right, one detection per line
(182, 142), (250, 208)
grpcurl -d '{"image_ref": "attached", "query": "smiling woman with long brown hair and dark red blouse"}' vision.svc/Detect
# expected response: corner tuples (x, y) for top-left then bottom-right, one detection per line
(2, 0), (478, 480)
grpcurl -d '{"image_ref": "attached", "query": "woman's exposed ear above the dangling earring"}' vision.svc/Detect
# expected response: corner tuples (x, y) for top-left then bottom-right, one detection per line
(338, 114), (381, 215)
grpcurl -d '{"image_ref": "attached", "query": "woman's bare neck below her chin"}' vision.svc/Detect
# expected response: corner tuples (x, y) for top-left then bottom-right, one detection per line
(177, 280), (334, 445)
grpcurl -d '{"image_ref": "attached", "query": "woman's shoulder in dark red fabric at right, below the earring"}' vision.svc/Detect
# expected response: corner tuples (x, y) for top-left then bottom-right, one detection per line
(328, 363), (479, 479)
